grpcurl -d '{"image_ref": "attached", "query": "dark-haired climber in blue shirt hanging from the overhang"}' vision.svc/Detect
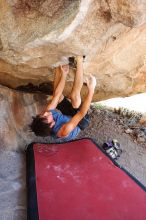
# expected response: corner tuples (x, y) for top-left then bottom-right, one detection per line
(30, 56), (96, 143)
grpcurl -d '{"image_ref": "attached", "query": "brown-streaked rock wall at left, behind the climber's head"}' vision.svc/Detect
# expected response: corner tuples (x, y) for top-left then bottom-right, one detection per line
(0, 86), (50, 150)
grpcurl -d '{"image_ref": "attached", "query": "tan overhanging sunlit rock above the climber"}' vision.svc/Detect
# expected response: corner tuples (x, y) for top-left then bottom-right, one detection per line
(0, 0), (146, 101)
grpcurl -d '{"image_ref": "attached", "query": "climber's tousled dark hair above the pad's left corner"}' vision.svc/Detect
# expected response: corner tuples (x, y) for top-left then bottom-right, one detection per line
(30, 115), (51, 137)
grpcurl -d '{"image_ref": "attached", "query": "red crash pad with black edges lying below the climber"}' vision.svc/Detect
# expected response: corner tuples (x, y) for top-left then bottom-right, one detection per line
(28, 139), (146, 220)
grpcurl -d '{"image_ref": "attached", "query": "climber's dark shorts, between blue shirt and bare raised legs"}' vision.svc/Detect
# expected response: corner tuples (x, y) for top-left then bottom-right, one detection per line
(57, 97), (90, 130)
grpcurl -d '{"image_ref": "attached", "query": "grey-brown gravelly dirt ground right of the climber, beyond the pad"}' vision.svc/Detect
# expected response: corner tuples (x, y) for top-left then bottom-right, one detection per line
(78, 107), (146, 186)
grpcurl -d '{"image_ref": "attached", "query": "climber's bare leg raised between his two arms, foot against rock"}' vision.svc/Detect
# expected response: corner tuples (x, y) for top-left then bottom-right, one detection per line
(70, 56), (83, 108)
